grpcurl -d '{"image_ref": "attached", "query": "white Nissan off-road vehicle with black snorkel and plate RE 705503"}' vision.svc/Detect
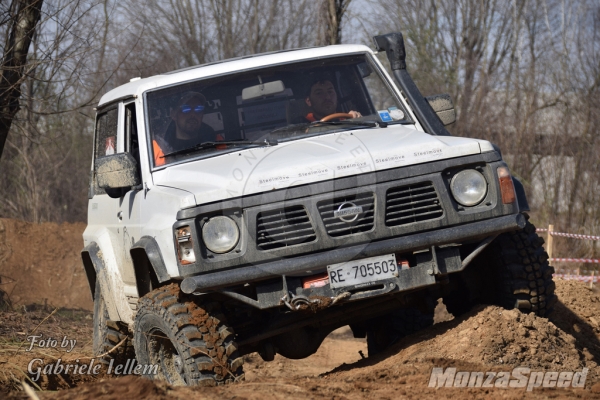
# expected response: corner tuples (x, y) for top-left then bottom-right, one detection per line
(82, 33), (556, 385)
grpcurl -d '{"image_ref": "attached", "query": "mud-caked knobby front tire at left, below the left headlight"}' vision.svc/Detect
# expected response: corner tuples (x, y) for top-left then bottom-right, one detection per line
(133, 284), (244, 386)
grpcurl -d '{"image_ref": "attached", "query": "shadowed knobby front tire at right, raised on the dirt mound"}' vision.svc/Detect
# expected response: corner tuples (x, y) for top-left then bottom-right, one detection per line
(444, 217), (557, 317)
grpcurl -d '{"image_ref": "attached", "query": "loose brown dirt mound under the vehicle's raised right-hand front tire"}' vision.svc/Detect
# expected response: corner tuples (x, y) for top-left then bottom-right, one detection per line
(366, 306), (596, 370)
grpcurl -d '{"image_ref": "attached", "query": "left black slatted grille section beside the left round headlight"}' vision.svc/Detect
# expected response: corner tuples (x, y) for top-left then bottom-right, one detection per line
(256, 206), (316, 250)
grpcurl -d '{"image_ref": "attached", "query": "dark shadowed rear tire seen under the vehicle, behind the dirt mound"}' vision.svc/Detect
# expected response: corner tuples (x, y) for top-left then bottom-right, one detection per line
(367, 308), (433, 357)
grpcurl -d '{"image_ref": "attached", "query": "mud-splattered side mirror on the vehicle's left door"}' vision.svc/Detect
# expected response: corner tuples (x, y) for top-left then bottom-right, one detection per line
(94, 153), (141, 197)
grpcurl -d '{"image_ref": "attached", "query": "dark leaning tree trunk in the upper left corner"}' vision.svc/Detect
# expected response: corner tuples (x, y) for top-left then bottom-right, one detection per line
(0, 0), (43, 156)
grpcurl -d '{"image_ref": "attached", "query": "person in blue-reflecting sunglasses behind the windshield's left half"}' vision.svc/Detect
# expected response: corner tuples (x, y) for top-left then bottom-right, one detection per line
(152, 92), (223, 166)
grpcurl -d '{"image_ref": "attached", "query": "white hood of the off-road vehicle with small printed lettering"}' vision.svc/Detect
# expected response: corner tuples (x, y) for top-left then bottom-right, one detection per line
(153, 125), (493, 207)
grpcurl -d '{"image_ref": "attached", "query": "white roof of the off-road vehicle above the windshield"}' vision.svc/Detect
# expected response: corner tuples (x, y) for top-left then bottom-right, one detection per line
(98, 44), (373, 107)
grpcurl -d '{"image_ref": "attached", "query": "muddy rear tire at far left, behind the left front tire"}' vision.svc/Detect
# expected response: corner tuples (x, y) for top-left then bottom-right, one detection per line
(92, 280), (135, 367)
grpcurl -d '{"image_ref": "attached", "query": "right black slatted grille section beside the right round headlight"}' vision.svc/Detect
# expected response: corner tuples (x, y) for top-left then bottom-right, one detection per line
(385, 182), (444, 226)
